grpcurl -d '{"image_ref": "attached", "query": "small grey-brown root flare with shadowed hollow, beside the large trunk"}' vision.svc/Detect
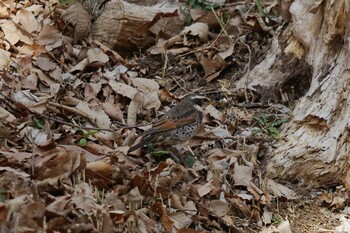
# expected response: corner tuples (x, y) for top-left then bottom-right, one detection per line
(234, 24), (312, 103)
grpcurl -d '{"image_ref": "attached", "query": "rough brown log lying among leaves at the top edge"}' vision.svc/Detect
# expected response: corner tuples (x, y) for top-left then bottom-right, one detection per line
(92, 0), (182, 54)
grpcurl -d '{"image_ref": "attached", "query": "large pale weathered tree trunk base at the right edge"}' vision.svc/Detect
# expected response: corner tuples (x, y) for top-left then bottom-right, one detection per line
(268, 0), (350, 190)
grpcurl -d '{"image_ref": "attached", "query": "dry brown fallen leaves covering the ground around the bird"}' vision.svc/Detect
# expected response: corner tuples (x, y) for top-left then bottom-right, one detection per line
(0, 0), (297, 233)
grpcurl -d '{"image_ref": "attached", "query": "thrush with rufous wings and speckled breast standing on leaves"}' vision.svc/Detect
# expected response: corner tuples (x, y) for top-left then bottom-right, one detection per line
(128, 94), (209, 152)
